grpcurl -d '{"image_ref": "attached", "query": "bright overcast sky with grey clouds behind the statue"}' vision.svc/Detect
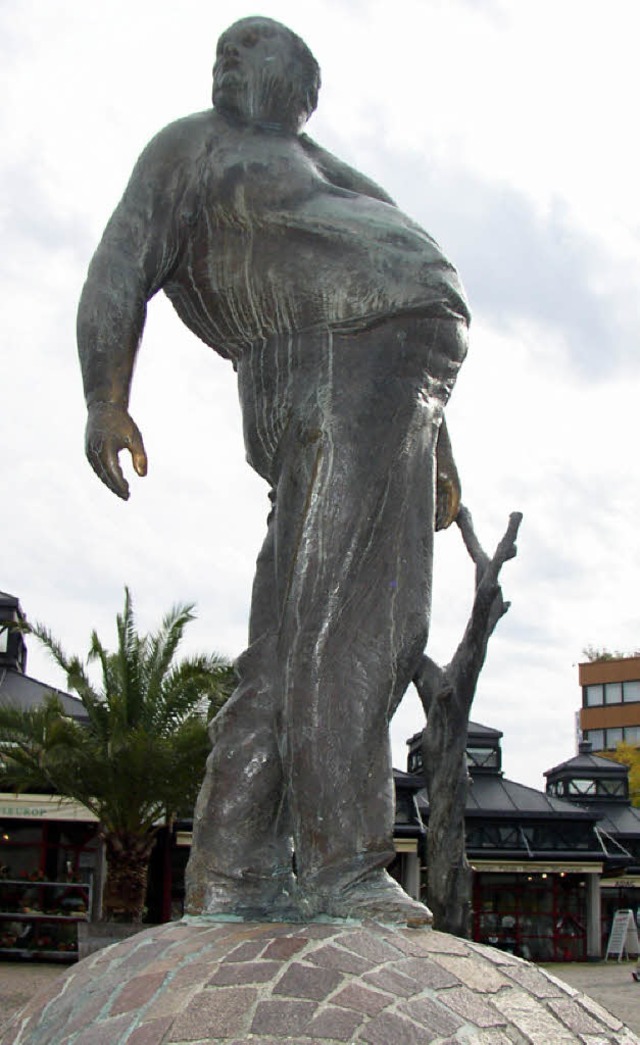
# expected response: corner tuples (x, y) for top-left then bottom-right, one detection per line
(0, 0), (640, 787)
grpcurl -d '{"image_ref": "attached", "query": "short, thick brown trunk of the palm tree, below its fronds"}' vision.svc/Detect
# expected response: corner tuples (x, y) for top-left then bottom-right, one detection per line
(102, 831), (156, 923)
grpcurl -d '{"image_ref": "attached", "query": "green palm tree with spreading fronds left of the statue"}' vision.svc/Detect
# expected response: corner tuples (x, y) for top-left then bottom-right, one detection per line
(0, 588), (234, 922)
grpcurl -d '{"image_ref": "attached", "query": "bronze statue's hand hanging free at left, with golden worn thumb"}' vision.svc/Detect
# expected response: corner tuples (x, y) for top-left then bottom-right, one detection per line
(85, 402), (147, 501)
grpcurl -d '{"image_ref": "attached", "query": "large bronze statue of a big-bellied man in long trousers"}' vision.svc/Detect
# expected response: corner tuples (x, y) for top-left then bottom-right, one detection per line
(78, 18), (468, 922)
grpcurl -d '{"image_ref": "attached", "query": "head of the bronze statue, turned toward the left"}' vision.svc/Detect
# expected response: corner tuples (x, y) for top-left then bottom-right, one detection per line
(212, 18), (320, 133)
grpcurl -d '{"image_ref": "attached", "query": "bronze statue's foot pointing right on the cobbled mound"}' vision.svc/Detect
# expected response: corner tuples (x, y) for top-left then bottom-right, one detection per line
(310, 870), (433, 926)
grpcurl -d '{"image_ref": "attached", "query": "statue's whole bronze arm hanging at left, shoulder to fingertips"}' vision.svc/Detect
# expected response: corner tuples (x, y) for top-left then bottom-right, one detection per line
(77, 118), (204, 500)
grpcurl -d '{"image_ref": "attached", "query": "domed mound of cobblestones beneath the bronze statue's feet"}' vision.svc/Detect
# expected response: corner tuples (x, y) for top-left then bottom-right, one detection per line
(0, 919), (640, 1045)
